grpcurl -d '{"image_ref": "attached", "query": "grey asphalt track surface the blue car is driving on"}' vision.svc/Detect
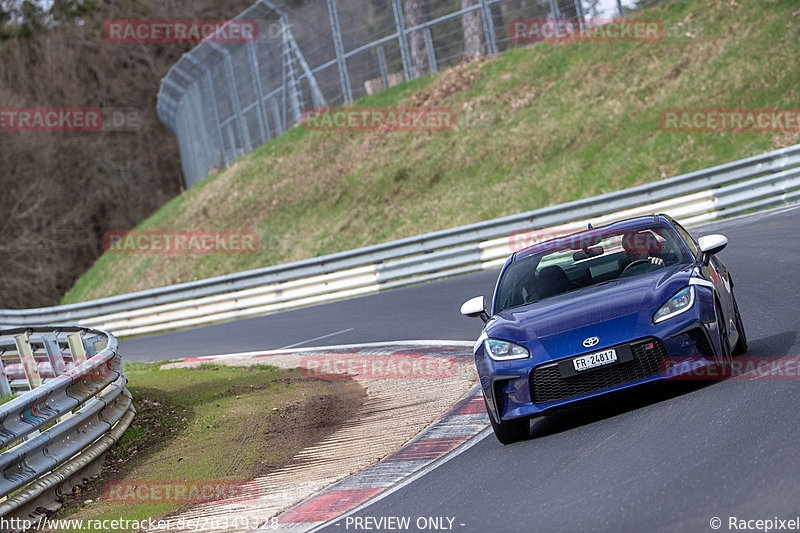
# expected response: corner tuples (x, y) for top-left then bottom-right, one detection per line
(121, 208), (800, 532)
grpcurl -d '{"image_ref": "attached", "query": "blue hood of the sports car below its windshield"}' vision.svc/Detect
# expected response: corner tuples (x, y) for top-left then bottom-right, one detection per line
(486, 265), (691, 355)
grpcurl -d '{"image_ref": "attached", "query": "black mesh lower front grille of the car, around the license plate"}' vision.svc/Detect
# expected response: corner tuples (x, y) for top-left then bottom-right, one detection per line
(530, 338), (668, 403)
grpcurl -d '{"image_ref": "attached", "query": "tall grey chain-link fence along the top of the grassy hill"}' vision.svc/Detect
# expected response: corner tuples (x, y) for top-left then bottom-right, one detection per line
(158, 0), (668, 186)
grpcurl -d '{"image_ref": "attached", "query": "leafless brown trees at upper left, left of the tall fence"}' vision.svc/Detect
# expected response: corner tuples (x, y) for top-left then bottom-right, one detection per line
(0, 0), (252, 308)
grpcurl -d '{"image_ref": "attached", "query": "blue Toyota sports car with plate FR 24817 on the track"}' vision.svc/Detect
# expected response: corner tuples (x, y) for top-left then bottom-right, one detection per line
(461, 214), (747, 444)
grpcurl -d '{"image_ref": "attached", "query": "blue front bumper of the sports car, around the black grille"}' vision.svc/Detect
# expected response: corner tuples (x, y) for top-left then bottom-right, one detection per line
(475, 302), (719, 420)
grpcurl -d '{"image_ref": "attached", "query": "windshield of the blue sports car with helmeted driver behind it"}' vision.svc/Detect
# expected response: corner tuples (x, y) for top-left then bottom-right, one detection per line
(495, 225), (691, 313)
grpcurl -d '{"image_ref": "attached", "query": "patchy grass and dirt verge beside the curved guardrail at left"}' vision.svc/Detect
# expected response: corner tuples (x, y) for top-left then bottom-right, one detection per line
(45, 363), (364, 531)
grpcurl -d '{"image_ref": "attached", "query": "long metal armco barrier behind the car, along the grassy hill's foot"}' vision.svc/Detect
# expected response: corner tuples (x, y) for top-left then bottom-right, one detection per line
(0, 145), (800, 335)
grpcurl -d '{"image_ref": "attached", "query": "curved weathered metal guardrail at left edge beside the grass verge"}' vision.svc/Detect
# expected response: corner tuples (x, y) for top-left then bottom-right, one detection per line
(0, 326), (135, 518)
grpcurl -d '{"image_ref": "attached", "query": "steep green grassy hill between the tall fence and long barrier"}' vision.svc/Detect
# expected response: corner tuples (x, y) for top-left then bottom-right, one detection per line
(64, 0), (800, 303)
